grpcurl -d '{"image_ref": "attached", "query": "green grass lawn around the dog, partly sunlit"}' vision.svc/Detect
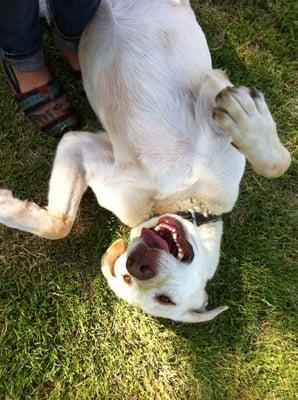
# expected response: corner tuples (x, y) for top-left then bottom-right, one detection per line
(0, 0), (298, 400)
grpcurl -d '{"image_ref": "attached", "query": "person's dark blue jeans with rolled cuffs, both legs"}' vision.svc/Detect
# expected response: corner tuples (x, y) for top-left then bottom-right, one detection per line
(0, 0), (100, 72)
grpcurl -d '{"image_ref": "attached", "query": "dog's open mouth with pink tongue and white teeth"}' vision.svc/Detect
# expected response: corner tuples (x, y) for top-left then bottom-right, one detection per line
(141, 216), (194, 262)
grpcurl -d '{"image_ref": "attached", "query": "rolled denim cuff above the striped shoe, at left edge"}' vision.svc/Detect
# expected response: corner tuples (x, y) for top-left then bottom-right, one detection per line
(0, 49), (45, 72)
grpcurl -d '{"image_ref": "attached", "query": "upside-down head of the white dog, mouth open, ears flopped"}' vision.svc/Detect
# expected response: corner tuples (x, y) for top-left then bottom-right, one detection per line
(102, 215), (227, 322)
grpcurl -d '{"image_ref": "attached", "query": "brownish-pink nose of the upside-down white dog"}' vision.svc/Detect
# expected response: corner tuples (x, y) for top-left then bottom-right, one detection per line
(126, 243), (156, 281)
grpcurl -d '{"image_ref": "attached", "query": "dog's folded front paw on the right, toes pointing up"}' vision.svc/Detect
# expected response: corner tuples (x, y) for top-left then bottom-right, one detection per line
(213, 86), (291, 178)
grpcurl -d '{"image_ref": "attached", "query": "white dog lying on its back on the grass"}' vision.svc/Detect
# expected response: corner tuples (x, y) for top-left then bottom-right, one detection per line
(0, 0), (290, 322)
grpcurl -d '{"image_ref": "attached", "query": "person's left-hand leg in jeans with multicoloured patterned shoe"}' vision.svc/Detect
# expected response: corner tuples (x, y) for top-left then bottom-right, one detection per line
(0, 0), (78, 136)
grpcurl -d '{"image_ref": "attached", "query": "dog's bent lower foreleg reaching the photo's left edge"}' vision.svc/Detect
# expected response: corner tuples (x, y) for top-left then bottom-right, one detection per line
(0, 135), (87, 239)
